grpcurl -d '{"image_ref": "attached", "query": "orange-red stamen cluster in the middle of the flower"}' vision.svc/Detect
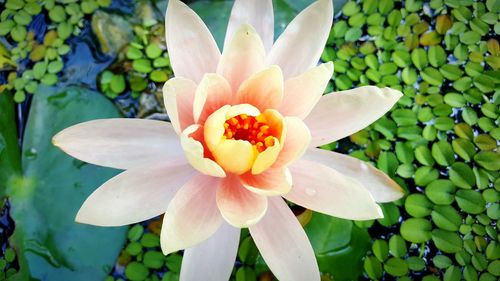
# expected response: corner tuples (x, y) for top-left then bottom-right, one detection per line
(223, 114), (274, 153)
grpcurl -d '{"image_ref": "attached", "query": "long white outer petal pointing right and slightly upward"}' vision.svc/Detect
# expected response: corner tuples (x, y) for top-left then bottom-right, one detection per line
(304, 86), (403, 147)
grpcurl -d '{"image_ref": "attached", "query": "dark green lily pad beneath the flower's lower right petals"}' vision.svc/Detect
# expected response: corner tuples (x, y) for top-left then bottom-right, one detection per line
(305, 213), (371, 280)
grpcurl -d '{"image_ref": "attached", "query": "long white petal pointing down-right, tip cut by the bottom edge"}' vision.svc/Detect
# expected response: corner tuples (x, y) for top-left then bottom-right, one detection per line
(249, 197), (320, 281)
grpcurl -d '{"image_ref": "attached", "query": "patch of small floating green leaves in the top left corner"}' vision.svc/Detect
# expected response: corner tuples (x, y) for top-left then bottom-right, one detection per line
(0, 0), (111, 102)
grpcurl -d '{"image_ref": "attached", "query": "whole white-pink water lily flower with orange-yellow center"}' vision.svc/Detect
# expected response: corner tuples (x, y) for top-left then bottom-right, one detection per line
(53, 0), (403, 281)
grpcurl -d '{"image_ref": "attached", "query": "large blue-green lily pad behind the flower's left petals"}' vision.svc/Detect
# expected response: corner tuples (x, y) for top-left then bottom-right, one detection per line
(8, 87), (126, 280)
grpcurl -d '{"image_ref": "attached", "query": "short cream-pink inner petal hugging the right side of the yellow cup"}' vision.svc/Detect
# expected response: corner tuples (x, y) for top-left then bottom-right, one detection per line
(273, 117), (311, 167)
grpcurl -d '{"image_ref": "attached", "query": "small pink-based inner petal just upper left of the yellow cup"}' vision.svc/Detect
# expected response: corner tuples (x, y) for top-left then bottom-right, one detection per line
(193, 73), (233, 124)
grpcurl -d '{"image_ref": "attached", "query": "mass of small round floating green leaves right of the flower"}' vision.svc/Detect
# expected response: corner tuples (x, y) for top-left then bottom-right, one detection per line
(320, 0), (500, 280)
